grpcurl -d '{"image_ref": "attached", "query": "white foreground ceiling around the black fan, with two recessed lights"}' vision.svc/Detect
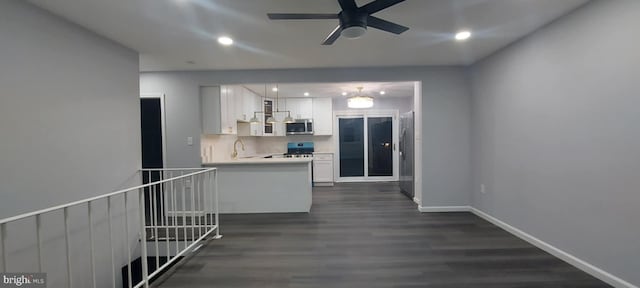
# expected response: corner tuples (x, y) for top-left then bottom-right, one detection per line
(30, 0), (588, 71)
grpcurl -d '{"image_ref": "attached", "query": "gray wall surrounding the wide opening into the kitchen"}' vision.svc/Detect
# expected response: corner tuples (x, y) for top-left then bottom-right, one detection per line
(140, 67), (470, 206)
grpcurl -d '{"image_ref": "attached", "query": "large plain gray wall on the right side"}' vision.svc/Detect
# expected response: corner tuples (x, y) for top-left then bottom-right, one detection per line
(471, 0), (640, 285)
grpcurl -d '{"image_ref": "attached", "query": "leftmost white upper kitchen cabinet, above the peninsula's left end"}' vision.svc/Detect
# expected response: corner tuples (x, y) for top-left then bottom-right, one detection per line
(200, 86), (237, 134)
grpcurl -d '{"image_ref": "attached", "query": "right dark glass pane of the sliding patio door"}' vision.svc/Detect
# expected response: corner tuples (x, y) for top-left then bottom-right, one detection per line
(367, 117), (393, 176)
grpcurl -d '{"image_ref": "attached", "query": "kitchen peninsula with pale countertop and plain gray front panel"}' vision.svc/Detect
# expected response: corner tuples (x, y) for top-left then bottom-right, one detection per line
(203, 158), (312, 214)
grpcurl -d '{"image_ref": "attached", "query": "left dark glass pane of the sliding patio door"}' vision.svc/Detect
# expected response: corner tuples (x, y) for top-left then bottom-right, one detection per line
(338, 118), (364, 177)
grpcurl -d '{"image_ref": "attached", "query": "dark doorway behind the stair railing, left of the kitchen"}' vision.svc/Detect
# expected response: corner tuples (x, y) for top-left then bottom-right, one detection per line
(140, 98), (164, 224)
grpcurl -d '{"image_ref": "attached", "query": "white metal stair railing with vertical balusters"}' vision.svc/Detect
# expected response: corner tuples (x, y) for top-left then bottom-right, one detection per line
(0, 168), (222, 288)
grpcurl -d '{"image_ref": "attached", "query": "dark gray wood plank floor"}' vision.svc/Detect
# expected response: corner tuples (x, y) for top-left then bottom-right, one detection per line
(152, 183), (609, 288)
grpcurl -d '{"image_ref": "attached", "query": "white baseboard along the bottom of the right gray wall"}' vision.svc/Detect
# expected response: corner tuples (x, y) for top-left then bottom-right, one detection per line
(470, 207), (638, 288)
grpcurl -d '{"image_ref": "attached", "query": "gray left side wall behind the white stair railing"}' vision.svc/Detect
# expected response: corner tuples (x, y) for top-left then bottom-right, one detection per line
(0, 0), (140, 287)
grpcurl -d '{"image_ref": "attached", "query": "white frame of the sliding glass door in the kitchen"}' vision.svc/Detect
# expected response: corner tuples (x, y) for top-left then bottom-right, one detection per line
(333, 109), (400, 183)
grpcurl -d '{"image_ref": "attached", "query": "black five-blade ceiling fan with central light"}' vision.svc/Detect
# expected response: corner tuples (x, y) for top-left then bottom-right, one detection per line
(267, 0), (409, 45)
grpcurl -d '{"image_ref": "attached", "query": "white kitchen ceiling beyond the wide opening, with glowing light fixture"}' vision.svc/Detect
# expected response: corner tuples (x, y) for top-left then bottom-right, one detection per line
(240, 82), (414, 98)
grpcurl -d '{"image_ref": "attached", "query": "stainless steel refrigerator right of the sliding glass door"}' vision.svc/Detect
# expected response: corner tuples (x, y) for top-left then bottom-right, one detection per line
(399, 111), (415, 200)
